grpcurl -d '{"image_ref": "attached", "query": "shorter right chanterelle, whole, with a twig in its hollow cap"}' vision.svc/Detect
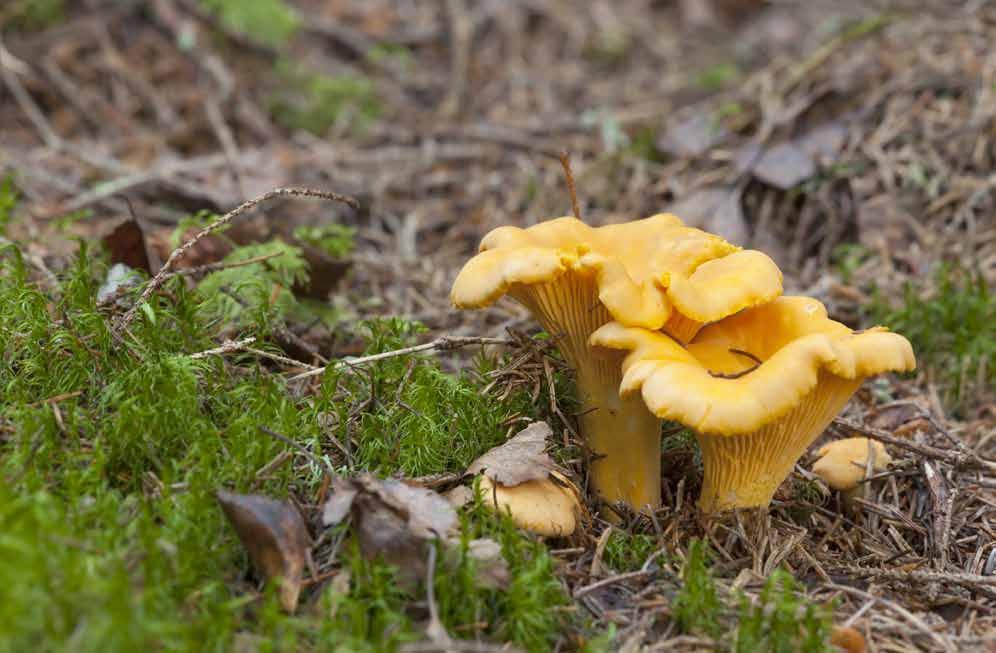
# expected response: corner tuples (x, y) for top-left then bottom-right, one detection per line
(591, 297), (916, 512)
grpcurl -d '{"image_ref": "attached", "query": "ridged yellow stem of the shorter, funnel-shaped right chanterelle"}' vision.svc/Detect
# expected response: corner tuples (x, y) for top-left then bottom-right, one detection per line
(697, 371), (863, 512)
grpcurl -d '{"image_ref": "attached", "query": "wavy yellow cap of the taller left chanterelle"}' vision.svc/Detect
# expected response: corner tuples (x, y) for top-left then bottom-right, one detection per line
(451, 214), (782, 329)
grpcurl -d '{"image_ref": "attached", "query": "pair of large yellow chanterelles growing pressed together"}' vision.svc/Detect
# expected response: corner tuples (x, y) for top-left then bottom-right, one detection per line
(452, 214), (916, 524)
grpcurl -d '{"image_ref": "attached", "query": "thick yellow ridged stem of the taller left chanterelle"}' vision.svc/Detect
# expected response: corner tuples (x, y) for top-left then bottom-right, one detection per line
(509, 274), (664, 510)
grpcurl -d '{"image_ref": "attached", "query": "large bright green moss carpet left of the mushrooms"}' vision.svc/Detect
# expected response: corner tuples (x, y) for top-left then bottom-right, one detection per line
(0, 237), (568, 652)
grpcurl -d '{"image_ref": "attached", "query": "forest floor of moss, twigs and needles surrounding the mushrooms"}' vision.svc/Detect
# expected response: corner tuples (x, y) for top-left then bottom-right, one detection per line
(0, 0), (996, 651)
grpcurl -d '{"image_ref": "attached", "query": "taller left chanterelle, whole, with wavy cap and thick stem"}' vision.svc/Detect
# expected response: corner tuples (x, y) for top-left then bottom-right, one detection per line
(452, 215), (782, 509)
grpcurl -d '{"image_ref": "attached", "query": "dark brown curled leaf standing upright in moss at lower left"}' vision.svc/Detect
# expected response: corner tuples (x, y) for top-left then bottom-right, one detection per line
(215, 490), (311, 613)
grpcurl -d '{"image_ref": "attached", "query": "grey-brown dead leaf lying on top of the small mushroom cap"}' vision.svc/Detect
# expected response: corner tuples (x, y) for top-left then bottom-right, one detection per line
(467, 422), (556, 487)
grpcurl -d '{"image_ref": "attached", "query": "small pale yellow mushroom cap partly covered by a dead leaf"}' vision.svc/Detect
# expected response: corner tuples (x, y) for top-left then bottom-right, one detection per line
(479, 472), (581, 537)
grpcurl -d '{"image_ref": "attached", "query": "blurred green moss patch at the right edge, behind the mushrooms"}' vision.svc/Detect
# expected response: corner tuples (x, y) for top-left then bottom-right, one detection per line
(866, 266), (996, 411)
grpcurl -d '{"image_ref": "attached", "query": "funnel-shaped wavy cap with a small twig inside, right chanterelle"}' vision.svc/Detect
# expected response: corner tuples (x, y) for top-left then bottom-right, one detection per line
(590, 297), (916, 435)
